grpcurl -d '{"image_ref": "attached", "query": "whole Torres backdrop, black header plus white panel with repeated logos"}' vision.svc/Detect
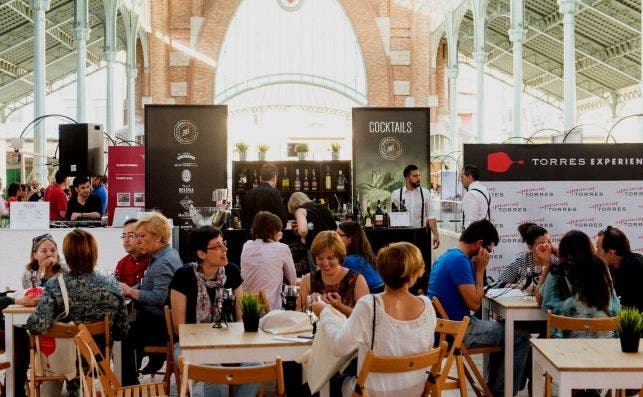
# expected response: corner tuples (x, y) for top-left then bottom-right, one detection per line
(463, 144), (643, 279)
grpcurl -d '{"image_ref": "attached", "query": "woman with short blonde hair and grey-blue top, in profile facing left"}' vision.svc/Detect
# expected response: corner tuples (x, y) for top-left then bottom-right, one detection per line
(119, 212), (183, 385)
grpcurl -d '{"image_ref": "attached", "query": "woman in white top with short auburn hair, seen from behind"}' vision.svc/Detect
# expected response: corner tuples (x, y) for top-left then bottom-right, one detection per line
(313, 242), (436, 397)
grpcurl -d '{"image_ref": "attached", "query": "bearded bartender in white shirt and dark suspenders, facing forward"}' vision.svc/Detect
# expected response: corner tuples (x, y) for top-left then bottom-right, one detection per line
(391, 164), (440, 248)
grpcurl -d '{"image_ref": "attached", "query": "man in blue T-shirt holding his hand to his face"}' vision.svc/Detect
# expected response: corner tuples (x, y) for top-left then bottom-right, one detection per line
(429, 219), (529, 396)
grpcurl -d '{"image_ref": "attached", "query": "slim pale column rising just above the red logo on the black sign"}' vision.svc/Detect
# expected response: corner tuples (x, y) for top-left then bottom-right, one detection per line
(509, 0), (525, 138)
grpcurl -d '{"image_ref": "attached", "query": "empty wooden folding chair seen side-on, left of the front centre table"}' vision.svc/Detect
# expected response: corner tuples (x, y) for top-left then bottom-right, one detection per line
(74, 324), (167, 397)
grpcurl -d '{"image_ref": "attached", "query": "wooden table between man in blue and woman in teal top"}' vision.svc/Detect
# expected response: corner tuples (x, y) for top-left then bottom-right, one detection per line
(482, 296), (546, 396)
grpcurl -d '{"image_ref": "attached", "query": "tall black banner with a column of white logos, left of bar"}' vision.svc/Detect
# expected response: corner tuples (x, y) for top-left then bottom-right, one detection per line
(145, 105), (228, 255)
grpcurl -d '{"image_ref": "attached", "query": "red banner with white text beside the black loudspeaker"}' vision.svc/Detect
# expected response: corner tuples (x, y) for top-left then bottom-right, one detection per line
(107, 146), (145, 225)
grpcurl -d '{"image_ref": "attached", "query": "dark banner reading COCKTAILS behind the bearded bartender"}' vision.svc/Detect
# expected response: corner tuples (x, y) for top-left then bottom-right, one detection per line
(353, 108), (430, 211)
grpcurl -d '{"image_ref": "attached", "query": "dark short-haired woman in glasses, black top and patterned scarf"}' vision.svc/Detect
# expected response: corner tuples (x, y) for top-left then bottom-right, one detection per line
(170, 226), (259, 397)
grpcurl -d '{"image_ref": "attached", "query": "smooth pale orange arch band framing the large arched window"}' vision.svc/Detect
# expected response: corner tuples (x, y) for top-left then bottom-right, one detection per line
(188, 0), (393, 106)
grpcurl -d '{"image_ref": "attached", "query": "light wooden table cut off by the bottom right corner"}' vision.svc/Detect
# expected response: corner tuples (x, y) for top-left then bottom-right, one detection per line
(531, 338), (643, 397)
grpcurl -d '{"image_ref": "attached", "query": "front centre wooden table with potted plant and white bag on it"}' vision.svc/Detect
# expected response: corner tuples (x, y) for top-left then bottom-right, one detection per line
(179, 322), (312, 364)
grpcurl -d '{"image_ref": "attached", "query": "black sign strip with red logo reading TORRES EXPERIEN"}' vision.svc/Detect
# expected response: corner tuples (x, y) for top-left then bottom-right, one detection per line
(464, 143), (643, 181)
